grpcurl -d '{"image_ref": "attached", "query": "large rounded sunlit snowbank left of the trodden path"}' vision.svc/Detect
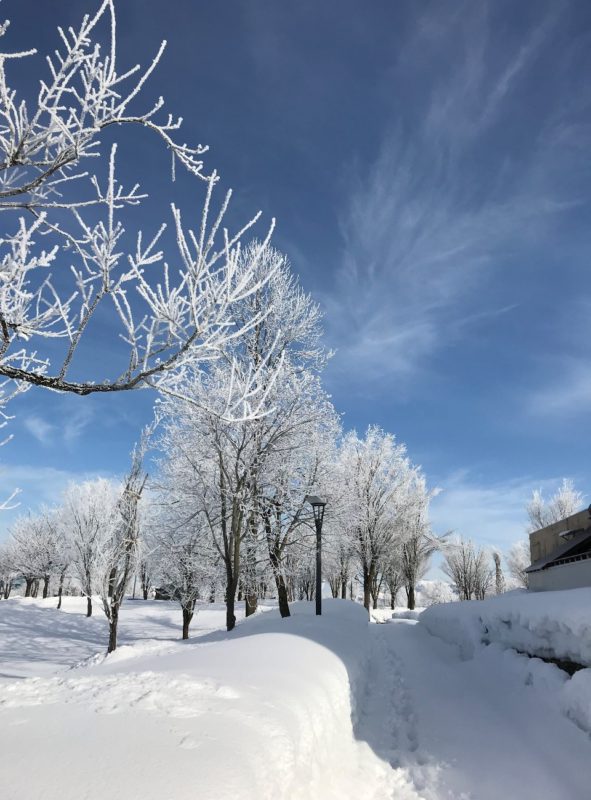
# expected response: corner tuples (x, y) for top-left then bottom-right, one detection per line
(0, 600), (394, 800)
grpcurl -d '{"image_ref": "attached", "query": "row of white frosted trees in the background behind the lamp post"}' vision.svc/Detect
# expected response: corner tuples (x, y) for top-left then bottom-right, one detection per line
(0, 234), (437, 649)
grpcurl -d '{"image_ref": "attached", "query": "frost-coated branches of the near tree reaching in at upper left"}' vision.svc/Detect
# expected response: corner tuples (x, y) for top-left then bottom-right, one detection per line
(0, 0), (276, 403)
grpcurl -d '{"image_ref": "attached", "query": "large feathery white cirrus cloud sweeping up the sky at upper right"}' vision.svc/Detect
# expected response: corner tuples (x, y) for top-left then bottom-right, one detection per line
(324, 3), (580, 388)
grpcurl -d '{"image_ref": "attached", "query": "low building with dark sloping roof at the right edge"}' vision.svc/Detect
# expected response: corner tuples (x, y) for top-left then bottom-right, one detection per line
(526, 506), (591, 591)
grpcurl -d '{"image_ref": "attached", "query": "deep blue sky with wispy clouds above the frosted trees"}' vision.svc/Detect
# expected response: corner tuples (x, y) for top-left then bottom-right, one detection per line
(0, 0), (591, 547)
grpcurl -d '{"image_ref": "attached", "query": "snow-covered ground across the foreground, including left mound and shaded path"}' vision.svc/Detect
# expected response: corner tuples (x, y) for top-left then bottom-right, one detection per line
(0, 598), (591, 800)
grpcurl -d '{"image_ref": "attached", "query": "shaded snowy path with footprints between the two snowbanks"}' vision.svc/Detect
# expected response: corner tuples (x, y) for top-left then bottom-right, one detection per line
(356, 620), (591, 800)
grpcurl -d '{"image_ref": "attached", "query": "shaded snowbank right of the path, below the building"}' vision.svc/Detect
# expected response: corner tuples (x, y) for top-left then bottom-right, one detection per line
(420, 589), (591, 666)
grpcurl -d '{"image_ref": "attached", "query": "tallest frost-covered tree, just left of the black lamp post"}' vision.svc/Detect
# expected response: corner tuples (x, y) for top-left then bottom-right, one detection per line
(155, 242), (335, 630)
